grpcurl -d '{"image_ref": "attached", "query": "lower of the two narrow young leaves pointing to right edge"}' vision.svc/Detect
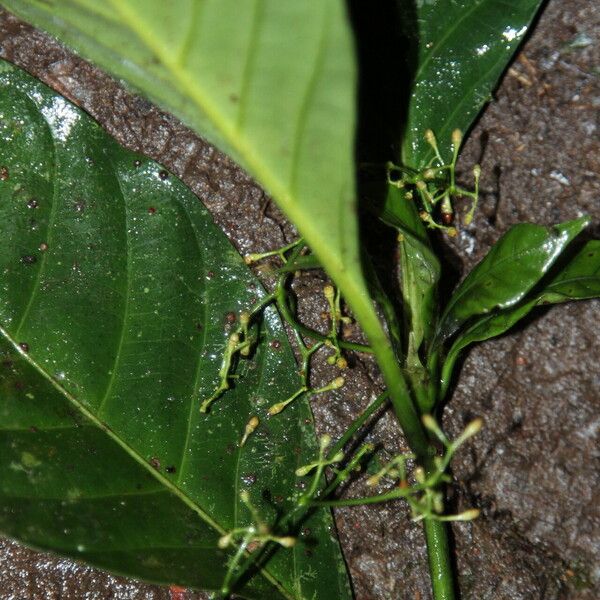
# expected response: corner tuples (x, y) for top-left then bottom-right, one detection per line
(441, 240), (600, 396)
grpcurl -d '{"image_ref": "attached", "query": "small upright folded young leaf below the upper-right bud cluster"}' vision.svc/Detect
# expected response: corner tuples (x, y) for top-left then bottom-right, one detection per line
(380, 184), (440, 356)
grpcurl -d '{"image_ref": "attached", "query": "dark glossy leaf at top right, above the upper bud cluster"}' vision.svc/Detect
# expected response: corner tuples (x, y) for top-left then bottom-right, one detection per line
(402, 0), (542, 169)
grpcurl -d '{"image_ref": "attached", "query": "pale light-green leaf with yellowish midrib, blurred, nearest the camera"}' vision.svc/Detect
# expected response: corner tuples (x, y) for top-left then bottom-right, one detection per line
(0, 0), (366, 318)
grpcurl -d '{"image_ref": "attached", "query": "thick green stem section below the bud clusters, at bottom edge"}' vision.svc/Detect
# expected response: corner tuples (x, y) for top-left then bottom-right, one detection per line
(423, 519), (455, 600)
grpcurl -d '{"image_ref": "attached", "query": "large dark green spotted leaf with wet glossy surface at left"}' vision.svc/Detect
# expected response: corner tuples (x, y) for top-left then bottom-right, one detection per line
(0, 58), (351, 599)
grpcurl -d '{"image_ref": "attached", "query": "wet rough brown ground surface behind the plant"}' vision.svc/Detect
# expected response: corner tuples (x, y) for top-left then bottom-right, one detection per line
(0, 0), (600, 600)
